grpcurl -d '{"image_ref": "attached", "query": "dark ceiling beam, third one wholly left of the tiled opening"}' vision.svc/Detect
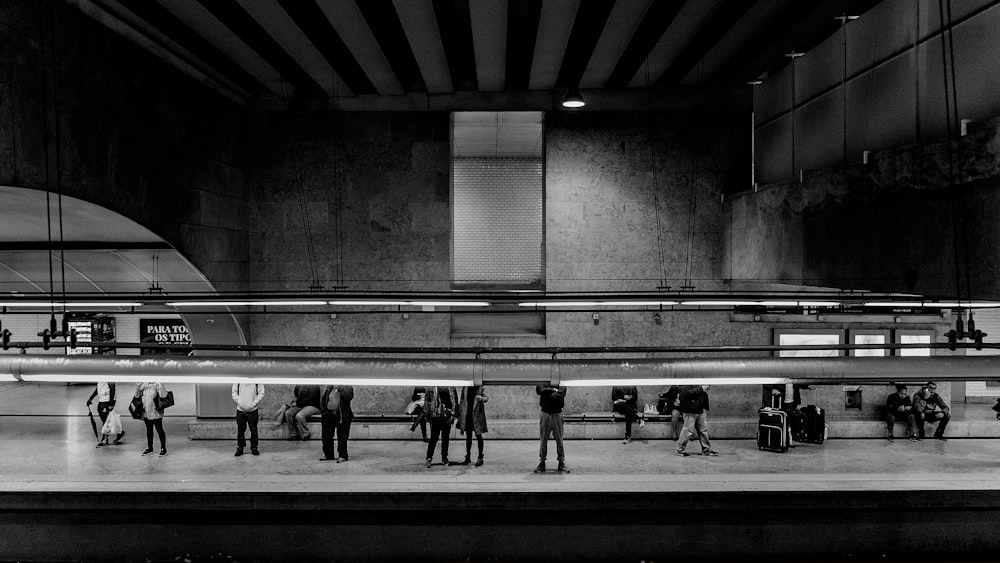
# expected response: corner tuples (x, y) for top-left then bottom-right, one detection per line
(198, 0), (324, 93)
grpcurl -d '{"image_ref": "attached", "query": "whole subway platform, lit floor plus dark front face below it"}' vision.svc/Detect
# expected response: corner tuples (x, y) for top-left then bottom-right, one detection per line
(0, 382), (1000, 562)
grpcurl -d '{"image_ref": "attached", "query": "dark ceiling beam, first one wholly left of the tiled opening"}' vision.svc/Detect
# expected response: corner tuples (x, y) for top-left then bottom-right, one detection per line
(356, 0), (427, 93)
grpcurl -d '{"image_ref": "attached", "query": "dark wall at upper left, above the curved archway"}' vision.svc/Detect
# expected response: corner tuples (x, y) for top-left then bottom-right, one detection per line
(0, 0), (248, 287)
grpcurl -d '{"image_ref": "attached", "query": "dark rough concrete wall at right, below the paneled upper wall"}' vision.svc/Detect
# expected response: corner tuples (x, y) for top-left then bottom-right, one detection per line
(726, 118), (1000, 299)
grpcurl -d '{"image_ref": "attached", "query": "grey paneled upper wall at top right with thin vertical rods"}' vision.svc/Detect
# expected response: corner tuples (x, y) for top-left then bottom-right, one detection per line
(755, 0), (1000, 183)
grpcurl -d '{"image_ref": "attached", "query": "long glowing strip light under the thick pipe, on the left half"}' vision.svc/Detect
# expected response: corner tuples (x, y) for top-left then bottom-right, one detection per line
(18, 373), (473, 387)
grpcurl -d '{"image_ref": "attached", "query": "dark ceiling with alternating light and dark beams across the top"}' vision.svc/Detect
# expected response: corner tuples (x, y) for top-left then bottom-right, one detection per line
(68, 0), (878, 110)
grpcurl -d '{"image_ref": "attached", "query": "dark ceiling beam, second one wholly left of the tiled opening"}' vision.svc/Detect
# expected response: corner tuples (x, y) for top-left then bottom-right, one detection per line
(278, 0), (377, 95)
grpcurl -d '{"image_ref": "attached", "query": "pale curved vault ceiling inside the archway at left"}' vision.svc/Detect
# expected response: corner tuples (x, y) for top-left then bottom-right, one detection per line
(0, 186), (212, 296)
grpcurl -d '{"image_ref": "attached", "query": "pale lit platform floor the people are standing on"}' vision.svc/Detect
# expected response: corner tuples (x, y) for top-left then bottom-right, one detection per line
(0, 384), (1000, 492)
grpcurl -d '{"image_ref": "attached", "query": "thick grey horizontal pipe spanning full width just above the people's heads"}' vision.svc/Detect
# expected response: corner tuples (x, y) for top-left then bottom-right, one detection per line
(0, 355), (1000, 385)
